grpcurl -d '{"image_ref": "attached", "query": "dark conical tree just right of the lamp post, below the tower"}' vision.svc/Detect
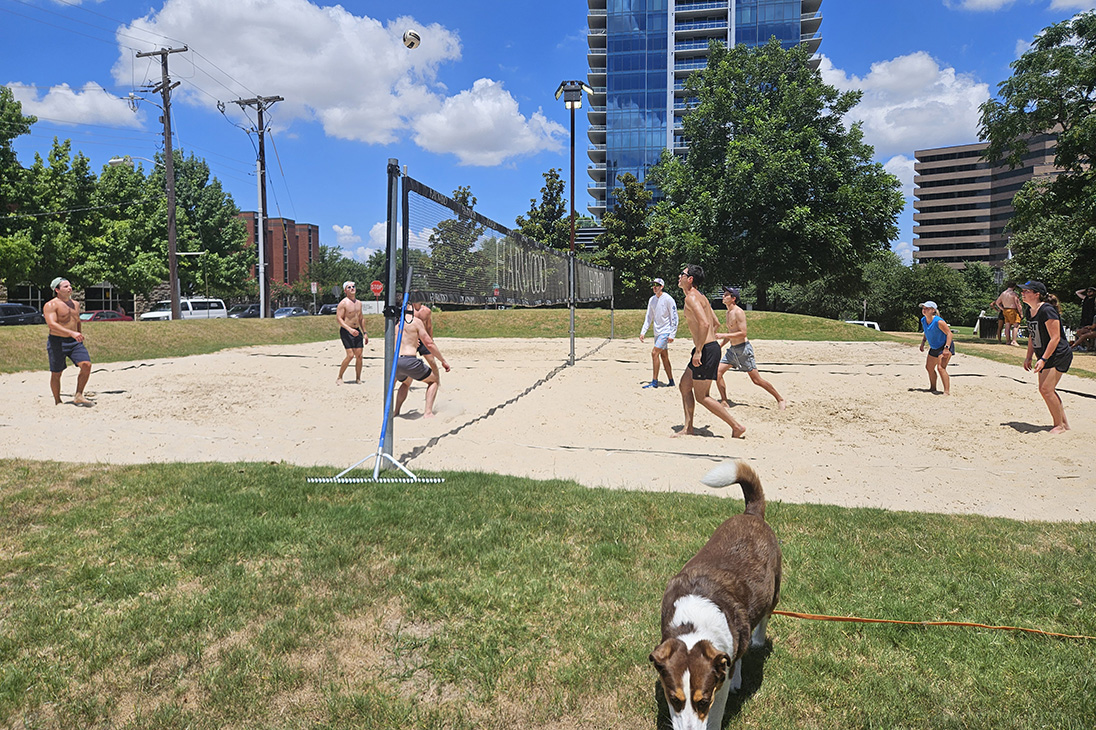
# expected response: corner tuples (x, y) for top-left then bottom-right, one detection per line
(594, 172), (677, 307)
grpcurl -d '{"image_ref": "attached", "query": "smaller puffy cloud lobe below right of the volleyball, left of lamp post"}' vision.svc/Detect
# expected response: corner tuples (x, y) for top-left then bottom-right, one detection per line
(412, 79), (567, 167)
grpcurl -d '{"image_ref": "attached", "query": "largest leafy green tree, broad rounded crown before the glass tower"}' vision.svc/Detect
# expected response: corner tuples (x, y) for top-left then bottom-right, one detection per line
(651, 39), (903, 308)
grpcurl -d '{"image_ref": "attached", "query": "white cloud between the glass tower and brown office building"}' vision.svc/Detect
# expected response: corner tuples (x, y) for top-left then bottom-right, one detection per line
(820, 52), (990, 158)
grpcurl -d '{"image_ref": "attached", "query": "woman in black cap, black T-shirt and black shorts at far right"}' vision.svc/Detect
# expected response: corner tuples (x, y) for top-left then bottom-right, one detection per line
(1020, 281), (1073, 434)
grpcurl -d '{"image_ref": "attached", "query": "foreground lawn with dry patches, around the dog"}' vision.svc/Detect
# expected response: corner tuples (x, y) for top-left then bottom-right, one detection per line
(0, 460), (1096, 730)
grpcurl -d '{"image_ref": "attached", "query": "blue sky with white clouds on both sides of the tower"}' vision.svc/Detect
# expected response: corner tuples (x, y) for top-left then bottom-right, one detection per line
(0, 0), (1096, 260)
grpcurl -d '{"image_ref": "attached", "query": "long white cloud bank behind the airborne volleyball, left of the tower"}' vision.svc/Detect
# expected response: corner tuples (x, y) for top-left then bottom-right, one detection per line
(106, 0), (561, 164)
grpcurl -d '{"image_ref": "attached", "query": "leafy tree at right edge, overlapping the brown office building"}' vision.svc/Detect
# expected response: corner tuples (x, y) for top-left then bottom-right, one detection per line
(979, 12), (1096, 290)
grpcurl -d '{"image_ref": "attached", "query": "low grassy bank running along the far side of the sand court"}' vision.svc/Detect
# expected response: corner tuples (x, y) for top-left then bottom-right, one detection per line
(0, 309), (889, 373)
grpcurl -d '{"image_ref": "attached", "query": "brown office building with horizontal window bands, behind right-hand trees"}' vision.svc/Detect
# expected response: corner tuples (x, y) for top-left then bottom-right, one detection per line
(913, 135), (1059, 269)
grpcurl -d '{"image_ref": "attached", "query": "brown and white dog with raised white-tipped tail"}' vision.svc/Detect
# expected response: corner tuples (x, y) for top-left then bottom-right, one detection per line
(649, 461), (780, 730)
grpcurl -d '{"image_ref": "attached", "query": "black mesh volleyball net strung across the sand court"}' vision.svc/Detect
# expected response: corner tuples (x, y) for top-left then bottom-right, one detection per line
(396, 175), (613, 307)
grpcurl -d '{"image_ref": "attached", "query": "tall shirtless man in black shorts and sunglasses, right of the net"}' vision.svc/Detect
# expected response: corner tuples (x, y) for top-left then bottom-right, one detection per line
(676, 264), (746, 438)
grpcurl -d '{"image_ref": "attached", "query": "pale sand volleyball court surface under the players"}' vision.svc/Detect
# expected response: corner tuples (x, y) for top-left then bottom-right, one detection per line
(0, 339), (1096, 522)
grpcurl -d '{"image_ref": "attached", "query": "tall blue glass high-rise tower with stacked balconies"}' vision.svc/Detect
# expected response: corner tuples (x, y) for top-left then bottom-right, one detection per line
(586, 0), (822, 218)
